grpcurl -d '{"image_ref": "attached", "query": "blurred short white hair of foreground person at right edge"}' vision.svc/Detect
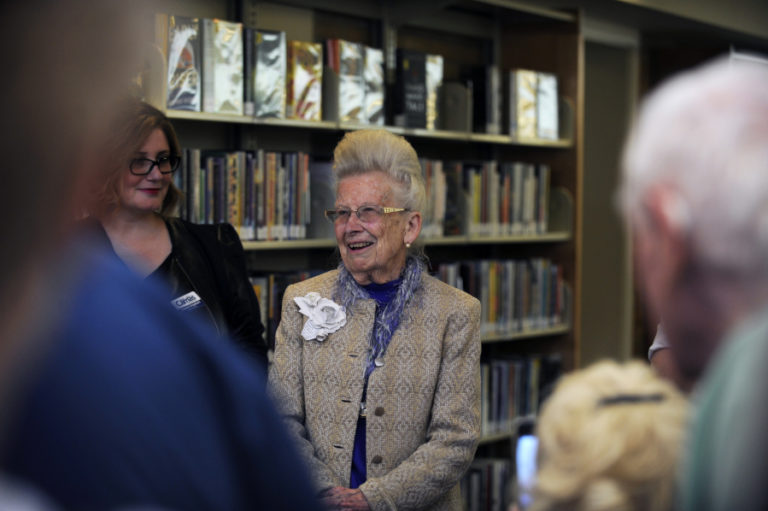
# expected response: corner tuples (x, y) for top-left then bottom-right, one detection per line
(620, 58), (768, 277)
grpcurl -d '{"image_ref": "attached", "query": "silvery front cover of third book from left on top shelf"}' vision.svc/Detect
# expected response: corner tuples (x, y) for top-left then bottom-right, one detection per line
(253, 30), (288, 119)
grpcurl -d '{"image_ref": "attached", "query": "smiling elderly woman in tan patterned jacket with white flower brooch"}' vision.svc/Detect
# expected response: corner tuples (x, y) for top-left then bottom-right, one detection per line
(270, 130), (480, 509)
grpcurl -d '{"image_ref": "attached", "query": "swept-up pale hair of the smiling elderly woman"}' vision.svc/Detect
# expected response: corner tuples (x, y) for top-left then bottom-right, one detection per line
(333, 129), (426, 215)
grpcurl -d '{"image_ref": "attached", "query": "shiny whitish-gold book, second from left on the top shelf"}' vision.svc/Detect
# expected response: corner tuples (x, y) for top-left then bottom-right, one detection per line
(203, 18), (244, 115)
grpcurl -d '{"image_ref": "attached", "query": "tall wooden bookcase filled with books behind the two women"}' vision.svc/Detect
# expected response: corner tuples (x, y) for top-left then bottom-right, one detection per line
(152, 0), (583, 509)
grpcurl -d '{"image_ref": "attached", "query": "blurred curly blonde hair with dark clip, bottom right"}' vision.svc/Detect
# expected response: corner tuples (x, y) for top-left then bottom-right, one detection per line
(532, 361), (688, 511)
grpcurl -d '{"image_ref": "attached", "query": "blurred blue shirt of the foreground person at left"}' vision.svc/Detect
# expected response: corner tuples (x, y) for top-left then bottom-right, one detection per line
(2, 243), (318, 510)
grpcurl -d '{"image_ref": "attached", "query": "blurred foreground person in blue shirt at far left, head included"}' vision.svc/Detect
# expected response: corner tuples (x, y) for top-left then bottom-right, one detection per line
(0, 0), (316, 510)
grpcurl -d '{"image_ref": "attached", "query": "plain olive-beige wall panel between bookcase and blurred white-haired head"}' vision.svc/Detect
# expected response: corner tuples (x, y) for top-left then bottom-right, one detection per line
(581, 42), (637, 365)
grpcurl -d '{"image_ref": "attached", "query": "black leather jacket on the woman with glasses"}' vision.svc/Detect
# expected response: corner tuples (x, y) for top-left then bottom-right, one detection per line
(85, 218), (267, 368)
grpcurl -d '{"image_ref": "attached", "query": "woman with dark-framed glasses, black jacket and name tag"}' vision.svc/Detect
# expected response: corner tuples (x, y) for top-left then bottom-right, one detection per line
(88, 99), (267, 364)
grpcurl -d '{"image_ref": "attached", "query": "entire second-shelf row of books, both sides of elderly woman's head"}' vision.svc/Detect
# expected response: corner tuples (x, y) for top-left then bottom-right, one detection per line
(174, 148), (550, 241)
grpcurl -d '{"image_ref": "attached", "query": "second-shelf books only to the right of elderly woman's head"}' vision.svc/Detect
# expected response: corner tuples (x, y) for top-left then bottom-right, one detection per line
(421, 159), (551, 238)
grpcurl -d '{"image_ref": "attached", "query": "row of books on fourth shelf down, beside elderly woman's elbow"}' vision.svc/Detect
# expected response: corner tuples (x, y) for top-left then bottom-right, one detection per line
(480, 355), (562, 435)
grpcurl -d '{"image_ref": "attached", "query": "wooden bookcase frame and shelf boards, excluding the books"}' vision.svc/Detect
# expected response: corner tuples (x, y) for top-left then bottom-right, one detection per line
(156, 0), (584, 506)
